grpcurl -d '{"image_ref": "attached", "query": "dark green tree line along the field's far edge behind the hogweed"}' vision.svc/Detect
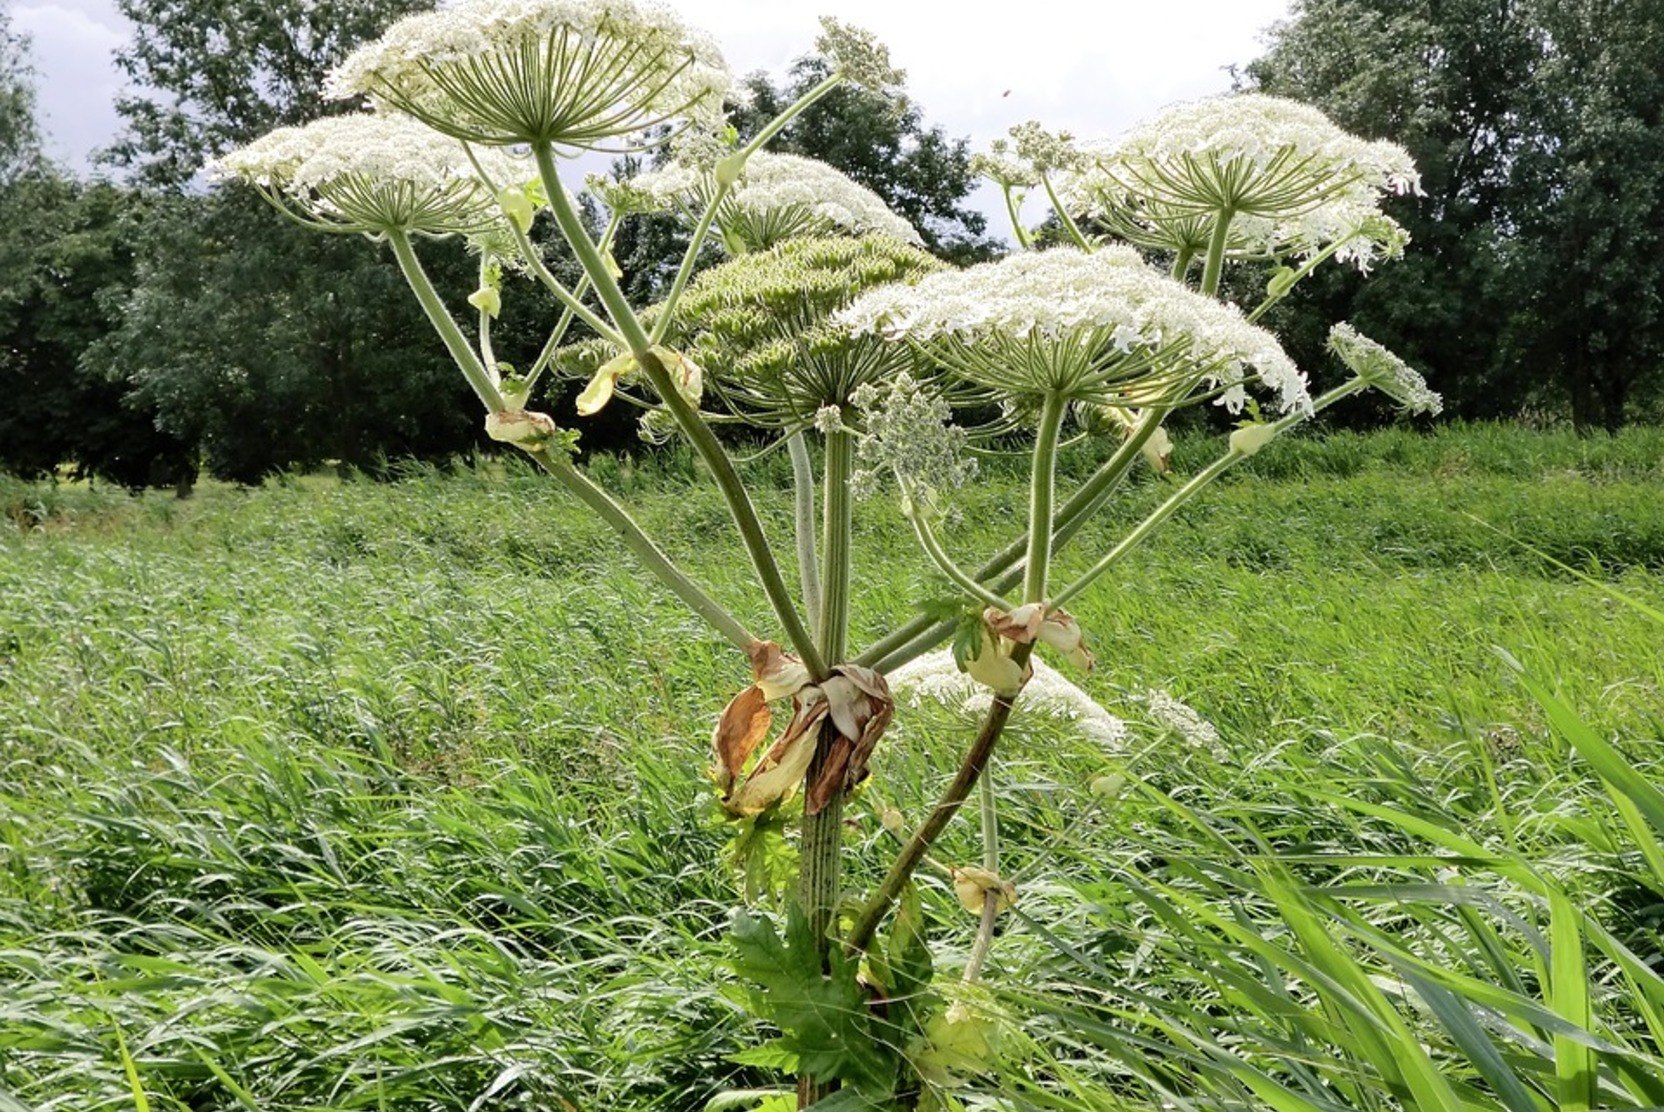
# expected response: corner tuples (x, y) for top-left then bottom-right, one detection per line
(0, 0), (1664, 489)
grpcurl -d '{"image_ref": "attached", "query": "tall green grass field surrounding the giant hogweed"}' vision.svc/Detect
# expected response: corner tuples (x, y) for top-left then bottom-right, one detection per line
(0, 426), (1664, 1112)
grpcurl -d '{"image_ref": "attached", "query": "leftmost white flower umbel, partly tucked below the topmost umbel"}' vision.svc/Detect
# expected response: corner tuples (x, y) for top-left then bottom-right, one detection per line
(211, 113), (537, 235)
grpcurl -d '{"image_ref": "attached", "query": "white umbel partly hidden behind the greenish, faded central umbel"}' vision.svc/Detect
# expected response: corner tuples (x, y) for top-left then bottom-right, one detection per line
(619, 151), (922, 253)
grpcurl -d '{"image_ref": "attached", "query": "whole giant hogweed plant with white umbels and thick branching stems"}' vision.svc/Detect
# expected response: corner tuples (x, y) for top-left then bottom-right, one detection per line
(218, 0), (1438, 1107)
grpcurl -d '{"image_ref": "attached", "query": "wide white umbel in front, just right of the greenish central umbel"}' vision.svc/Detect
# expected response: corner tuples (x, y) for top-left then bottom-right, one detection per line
(837, 246), (1310, 410)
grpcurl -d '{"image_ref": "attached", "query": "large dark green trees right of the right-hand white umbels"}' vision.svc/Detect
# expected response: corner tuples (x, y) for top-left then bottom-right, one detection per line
(1243, 0), (1664, 428)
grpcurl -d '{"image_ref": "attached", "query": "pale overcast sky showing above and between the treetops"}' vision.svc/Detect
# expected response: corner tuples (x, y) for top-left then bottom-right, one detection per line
(0, 0), (1288, 230)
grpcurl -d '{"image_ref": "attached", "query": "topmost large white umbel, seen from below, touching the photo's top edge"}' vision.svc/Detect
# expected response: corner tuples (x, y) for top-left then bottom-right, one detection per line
(326, 0), (732, 150)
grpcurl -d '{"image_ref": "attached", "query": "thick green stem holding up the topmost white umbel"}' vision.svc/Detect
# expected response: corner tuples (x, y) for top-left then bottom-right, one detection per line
(532, 143), (827, 681)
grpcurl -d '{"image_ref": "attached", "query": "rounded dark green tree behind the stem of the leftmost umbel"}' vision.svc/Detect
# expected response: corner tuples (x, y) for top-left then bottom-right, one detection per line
(88, 190), (478, 483)
